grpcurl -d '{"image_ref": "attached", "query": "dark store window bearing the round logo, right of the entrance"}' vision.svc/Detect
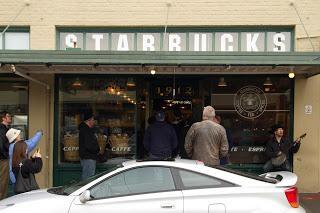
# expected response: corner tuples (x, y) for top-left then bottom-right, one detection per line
(211, 75), (292, 164)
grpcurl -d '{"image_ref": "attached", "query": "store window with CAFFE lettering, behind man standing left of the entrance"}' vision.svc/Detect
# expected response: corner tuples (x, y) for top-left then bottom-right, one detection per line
(58, 76), (137, 164)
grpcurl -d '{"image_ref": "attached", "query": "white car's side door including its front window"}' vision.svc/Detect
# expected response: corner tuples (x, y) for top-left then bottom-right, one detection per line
(69, 166), (183, 213)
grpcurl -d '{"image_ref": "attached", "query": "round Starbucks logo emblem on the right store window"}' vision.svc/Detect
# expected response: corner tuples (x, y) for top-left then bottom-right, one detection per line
(233, 86), (267, 118)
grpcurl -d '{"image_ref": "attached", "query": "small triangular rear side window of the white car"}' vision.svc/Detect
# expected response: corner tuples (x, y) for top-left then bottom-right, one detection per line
(178, 170), (233, 189)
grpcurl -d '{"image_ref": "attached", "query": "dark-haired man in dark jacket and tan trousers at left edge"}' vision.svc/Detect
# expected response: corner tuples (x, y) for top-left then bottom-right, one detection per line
(0, 111), (12, 200)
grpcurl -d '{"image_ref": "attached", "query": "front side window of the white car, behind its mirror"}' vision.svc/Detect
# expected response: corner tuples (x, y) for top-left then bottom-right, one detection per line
(90, 167), (175, 199)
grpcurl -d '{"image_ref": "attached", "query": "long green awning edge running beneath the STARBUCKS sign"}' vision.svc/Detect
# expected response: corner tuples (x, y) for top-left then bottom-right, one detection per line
(0, 50), (320, 66)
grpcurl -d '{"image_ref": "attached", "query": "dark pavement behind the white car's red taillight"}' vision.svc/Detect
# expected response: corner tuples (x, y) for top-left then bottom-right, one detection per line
(299, 193), (320, 213)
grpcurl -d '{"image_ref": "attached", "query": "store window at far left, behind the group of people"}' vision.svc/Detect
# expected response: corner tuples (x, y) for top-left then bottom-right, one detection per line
(0, 78), (29, 138)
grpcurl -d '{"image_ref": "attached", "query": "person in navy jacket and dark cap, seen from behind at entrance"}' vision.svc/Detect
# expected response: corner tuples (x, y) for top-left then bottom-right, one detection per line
(143, 111), (178, 160)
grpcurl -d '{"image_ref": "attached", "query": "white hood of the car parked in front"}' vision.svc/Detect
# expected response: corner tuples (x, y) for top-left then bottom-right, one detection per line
(0, 189), (75, 213)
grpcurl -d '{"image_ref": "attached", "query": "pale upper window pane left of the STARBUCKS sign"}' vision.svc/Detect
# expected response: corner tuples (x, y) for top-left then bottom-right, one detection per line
(4, 32), (29, 50)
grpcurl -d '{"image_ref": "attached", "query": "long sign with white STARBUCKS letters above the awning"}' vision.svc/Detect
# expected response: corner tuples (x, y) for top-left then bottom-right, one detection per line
(58, 30), (293, 52)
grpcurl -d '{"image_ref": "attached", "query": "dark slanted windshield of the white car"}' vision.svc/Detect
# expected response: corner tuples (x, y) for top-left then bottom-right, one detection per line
(48, 164), (123, 195)
